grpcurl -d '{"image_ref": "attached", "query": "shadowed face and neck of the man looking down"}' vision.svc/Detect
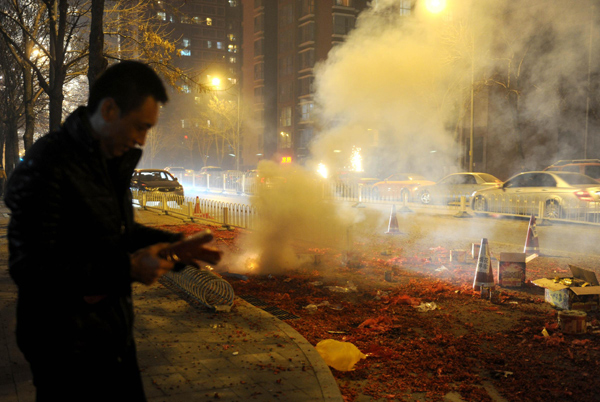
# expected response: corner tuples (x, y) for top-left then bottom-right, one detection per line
(100, 96), (159, 158)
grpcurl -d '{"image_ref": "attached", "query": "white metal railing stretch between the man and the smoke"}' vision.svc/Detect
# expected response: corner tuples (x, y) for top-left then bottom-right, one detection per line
(131, 189), (258, 229)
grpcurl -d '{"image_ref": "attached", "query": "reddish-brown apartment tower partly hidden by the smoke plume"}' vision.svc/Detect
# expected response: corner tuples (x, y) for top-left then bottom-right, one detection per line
(241, 0), (367, 165)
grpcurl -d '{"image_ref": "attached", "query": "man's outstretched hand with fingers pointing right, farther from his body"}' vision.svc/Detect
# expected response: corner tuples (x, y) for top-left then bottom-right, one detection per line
(159, 229), (222, 271)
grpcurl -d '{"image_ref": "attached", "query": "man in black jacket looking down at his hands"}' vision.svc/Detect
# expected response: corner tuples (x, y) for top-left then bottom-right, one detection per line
(5, 62), (210, 401)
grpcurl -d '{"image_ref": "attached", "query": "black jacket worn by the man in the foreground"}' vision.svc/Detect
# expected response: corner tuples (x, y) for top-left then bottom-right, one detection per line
(5, 108), (180, 359)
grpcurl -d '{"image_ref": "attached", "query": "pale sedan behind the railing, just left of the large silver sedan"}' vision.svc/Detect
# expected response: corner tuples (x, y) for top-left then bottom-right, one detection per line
(416, 172), (502, 204)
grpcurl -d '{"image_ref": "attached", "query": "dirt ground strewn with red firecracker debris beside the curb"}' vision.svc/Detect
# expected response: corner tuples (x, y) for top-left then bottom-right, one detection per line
(154, 224), (600, 402)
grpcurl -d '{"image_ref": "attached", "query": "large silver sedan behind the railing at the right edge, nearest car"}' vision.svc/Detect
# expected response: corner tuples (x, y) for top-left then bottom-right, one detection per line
(471, 171), (600, 218)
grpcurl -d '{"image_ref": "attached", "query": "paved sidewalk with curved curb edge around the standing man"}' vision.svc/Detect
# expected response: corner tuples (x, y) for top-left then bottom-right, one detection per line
(0, 204), (343, 402)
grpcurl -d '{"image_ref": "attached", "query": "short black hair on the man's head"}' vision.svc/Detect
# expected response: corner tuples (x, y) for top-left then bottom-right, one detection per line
(88, 61), (169, 115)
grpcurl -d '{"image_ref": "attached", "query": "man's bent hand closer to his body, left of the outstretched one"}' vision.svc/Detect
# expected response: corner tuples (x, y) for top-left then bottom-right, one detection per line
(130, 243), (175, 285)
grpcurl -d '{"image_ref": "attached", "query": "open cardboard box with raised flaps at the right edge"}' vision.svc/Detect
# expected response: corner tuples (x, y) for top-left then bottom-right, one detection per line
(533, 265), (600, 311)
